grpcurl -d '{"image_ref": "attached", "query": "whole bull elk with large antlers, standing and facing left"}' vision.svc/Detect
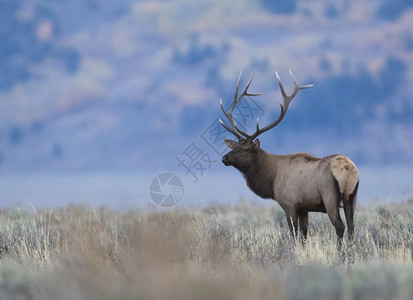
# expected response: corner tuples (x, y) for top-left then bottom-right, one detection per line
(219, 71), (359, 249)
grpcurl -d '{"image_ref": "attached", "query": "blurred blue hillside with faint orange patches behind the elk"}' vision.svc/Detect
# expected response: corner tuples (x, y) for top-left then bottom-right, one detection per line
(0, 0), (413, 172)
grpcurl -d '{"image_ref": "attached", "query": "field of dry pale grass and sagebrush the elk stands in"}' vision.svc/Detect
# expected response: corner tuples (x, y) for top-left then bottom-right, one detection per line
(0, 202), (413, 300)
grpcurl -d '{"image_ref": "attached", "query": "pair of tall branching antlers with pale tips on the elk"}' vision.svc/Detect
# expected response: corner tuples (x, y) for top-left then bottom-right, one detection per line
(219, 71), (313, 141)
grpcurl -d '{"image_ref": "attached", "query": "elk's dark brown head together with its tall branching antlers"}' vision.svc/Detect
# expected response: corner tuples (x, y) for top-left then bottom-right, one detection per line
(219, 71), (313, 173)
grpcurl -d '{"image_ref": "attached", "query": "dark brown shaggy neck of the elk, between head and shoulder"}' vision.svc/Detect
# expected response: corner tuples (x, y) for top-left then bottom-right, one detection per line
(240, 148), (276, 199)
